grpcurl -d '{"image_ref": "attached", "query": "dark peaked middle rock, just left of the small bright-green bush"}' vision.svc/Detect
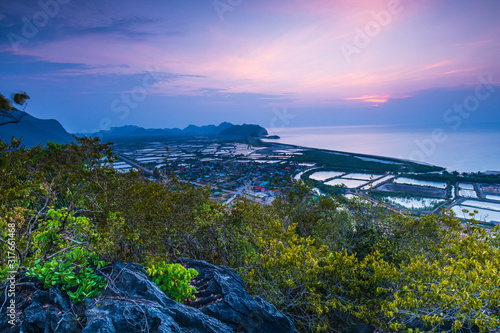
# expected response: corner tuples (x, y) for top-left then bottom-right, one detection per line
(82, 263), (233, 333)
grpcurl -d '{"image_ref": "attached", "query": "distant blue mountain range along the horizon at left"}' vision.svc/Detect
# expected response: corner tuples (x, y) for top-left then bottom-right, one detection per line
(0, 110), (268, 147)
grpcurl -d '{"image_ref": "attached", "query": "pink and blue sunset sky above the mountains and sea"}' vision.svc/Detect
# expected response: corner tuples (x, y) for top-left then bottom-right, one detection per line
(0, 0), (500, 133)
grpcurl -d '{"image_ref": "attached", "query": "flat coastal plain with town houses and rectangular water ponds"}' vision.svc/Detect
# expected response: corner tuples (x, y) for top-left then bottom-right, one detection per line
(108, 137), (500, 227)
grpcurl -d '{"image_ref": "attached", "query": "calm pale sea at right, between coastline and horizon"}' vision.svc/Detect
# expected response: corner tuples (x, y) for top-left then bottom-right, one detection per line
(268, 126), (500, 172)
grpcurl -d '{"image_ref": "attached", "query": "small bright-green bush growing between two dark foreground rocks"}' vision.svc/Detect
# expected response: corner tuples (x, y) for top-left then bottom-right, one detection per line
(147, 262), (198, 302)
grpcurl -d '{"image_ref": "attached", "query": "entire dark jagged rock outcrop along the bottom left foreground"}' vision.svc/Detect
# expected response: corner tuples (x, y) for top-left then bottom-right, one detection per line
(0, 259), (294, 333)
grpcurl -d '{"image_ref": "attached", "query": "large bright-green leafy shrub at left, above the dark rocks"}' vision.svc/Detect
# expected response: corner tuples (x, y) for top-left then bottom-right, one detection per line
(2, 209), (106, 302)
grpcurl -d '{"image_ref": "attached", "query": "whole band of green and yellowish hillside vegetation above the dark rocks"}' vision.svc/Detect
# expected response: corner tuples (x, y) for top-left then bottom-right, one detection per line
(0, 138), (500, 332)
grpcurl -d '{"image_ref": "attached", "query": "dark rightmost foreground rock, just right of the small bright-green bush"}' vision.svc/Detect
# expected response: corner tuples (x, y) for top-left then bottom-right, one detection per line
(176, 258), (295, 333)
